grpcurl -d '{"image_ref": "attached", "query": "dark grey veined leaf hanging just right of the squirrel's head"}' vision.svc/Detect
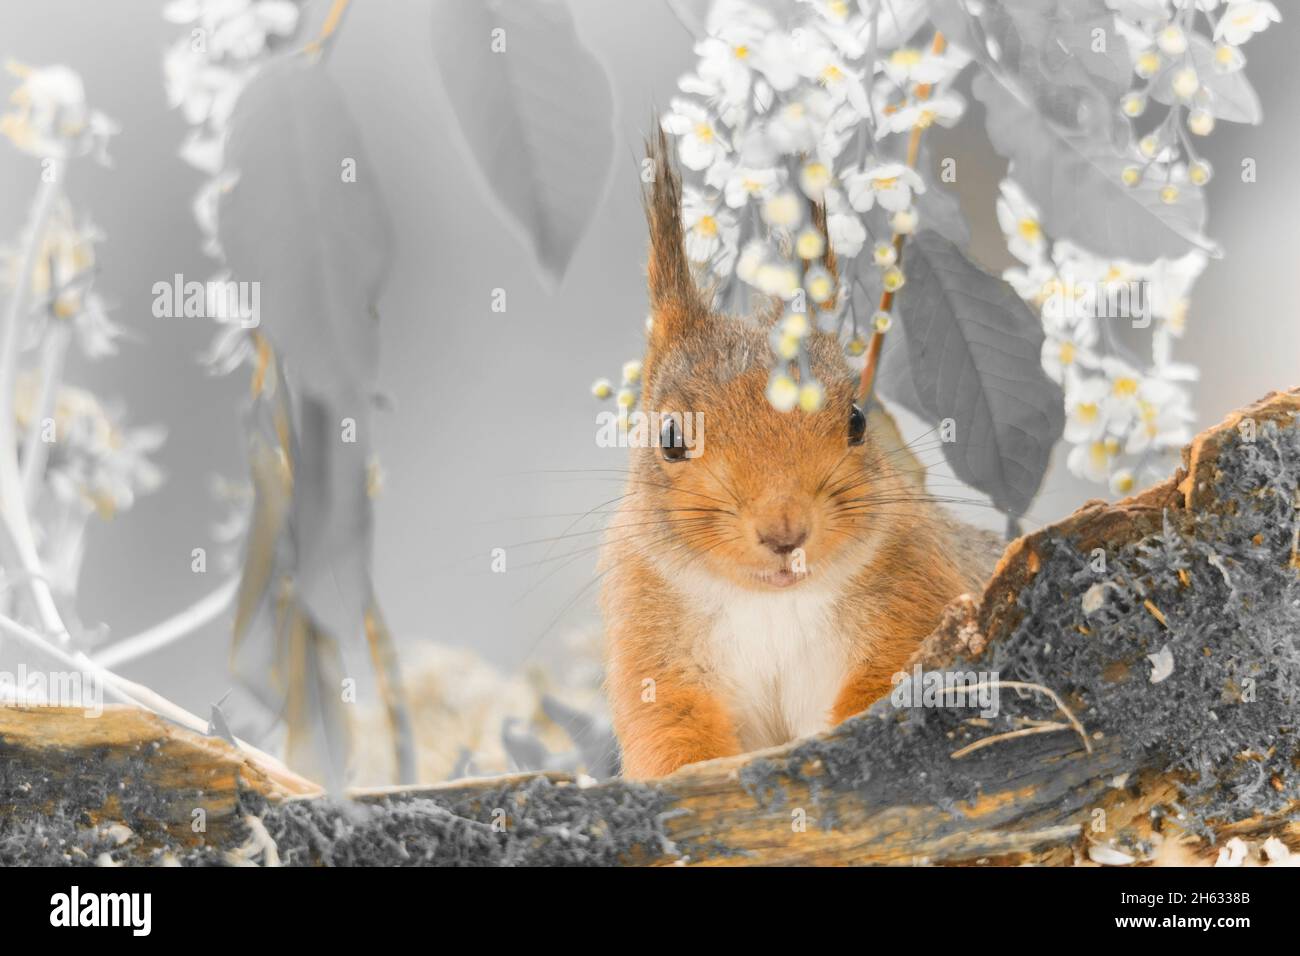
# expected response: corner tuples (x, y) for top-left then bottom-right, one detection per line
(898, 230), (1065, 516)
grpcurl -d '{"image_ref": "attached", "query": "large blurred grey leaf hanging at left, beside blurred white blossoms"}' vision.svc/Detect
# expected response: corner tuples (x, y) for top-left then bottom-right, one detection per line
(218, 59), (393, 394)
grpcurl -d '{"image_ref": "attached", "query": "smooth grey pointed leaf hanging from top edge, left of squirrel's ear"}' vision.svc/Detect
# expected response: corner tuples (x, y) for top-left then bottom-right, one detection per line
(433, 0), (614, 284)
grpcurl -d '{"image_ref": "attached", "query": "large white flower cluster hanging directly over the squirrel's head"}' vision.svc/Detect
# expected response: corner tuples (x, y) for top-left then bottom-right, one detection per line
(663, 0), (969, 411)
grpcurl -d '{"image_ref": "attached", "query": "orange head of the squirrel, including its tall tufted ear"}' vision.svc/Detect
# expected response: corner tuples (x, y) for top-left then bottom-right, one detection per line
(629, 127), (904, 591)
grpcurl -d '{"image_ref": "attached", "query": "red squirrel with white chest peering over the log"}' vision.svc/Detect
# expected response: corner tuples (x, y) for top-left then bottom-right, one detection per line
(601, 137), (1001, 778)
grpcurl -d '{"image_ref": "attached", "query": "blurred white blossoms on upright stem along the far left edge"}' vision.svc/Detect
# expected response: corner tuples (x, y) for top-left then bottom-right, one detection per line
(0, 65), (163, 594)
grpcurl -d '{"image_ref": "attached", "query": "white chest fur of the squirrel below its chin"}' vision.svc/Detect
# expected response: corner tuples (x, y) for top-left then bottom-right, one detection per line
(693, 574), (849, 750)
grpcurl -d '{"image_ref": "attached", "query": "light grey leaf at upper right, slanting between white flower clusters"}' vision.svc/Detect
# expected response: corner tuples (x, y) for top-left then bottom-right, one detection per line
(972, 75), (1217, 261)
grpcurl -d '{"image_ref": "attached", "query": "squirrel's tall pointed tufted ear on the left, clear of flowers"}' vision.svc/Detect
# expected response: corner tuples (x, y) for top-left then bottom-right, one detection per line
(644, 121), (707, 346)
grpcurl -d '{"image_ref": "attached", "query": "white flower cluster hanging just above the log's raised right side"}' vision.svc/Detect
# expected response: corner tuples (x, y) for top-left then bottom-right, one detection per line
(997, 179), (1206, 494)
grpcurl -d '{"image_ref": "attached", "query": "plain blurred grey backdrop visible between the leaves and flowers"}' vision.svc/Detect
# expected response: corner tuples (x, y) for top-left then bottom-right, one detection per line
(0, 0), (1300, 713)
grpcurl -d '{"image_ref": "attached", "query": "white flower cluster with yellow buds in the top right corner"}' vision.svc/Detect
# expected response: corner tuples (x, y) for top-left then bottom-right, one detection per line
(1108, 0), (1282, 203)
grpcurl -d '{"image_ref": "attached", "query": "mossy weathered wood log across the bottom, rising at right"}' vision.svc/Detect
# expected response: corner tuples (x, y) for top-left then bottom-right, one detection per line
(0, 389), (1300, 865)
